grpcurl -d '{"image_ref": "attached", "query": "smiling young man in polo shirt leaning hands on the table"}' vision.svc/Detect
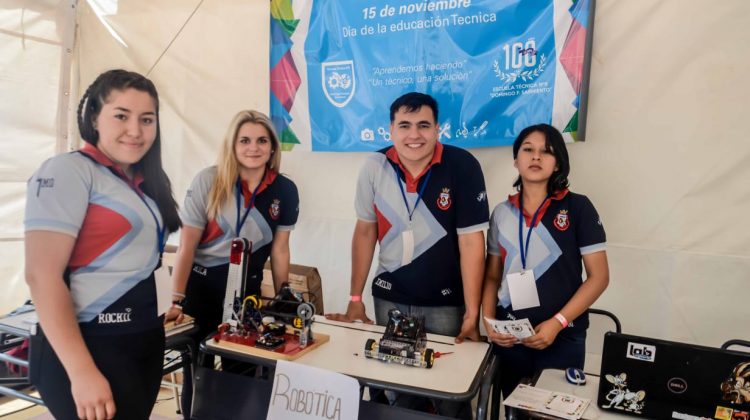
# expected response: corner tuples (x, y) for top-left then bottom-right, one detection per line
(329, 92), (489, 343)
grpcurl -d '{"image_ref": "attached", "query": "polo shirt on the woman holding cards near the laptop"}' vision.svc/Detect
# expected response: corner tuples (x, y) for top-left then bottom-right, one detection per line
(487, 189), (607, 333)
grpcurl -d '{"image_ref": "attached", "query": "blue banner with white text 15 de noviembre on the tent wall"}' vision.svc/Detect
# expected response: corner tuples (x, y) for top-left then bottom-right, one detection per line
(271, 0), (594, 151)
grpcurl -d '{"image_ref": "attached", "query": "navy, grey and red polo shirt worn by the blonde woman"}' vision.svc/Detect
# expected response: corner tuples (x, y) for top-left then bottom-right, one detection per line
(180, 166), (299, 278)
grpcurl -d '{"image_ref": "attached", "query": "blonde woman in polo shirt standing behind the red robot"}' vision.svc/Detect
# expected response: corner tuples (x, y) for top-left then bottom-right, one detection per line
(167, 111), (299, 346)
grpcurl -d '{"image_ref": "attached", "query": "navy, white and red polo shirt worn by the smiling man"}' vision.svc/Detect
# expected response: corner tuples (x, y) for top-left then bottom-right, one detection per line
(355, 143), (489, 306)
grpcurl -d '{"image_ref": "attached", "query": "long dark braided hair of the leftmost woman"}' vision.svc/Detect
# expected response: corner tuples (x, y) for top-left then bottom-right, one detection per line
(78, 70), (182, 232)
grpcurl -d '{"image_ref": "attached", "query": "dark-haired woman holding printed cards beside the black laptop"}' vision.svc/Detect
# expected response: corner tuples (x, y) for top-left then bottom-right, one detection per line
(482, 124), (609, 396)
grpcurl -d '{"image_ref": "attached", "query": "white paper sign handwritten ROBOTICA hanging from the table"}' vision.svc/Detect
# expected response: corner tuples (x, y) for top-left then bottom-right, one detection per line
(266, 360), (359, 420)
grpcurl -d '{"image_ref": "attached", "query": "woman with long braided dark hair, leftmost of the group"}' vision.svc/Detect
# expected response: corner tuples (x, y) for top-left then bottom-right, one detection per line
(24, 70), (180, 419)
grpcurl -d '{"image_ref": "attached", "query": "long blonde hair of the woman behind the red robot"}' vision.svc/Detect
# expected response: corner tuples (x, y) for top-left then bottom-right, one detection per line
(207, 110), (281, 220)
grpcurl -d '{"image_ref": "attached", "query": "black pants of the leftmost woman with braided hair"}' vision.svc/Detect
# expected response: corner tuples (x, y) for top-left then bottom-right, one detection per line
(31, 327), (164, 420)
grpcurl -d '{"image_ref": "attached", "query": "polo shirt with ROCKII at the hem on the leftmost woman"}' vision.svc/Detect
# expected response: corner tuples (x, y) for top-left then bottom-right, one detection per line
(24, 143), (164, 334)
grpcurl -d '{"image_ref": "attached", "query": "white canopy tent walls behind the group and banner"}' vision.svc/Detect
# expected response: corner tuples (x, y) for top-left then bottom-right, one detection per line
(0, 0), (750, 346)
